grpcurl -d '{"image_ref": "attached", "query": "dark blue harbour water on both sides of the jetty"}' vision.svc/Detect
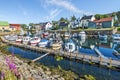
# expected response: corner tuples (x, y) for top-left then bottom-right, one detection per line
(8, 37), (120, 80)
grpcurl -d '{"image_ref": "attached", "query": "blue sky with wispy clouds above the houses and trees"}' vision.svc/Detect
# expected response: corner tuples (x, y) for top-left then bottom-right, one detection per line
(0, 0), (120, 24)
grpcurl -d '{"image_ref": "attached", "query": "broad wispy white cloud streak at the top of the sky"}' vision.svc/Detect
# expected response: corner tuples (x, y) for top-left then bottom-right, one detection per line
(45, 0), (92, 15)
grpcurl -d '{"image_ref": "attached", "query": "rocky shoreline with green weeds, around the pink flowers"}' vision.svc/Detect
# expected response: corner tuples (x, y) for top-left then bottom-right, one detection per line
(0, 45), (95, 80)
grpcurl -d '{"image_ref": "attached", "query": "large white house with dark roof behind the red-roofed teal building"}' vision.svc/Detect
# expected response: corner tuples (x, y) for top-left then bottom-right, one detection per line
(80, 15), (95, 27)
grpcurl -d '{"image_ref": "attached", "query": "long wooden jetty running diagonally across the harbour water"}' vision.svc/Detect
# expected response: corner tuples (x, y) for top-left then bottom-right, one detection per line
(1, 37), (120, 69)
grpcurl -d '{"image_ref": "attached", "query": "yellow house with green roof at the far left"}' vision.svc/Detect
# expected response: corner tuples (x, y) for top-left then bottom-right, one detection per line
(0, 21), (13, 32)
